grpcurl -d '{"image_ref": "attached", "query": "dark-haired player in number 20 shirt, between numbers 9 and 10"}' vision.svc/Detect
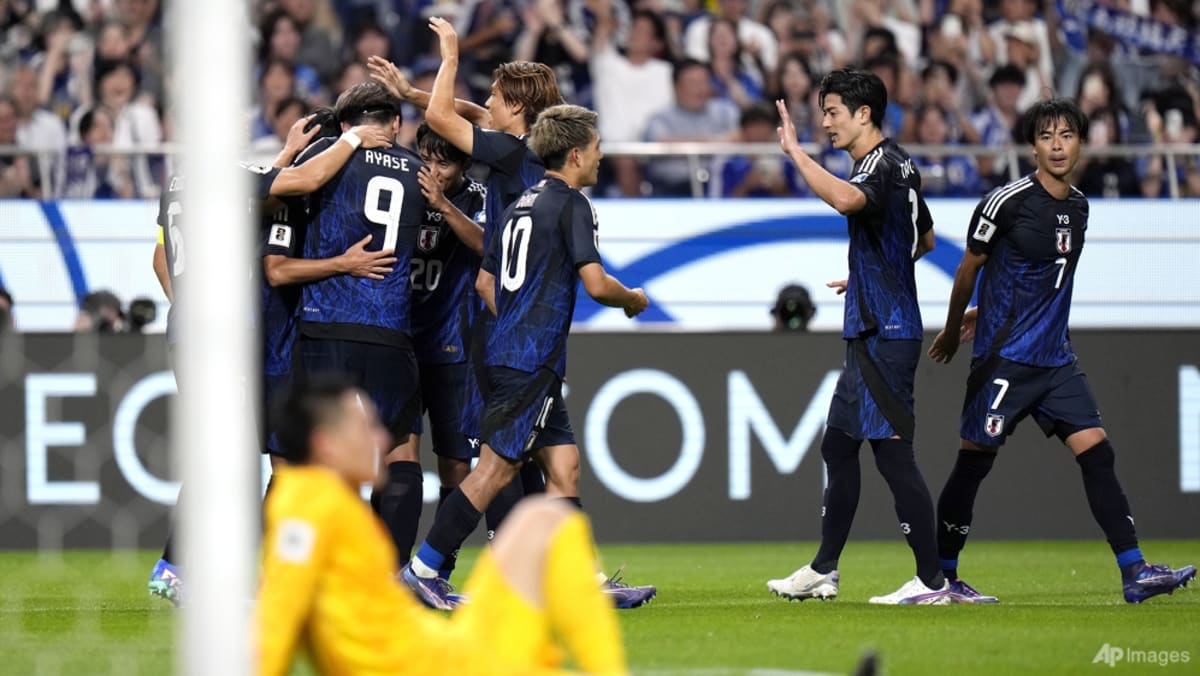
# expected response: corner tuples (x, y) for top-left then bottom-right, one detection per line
(410, 124), (487, 588)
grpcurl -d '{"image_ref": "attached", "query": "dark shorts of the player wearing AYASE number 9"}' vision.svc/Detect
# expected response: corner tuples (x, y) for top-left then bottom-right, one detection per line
(296, 336), (421, 450)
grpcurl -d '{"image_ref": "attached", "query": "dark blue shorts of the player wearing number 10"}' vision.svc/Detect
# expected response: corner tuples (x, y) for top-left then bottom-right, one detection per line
(481, 366), (575, 460)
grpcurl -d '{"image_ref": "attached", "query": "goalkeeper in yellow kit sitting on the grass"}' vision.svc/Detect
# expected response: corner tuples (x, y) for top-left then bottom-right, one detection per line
(254, 379), (626, 676)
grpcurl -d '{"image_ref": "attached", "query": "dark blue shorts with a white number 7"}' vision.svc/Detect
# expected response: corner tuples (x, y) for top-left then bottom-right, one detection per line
(959, 358), (1103, 447)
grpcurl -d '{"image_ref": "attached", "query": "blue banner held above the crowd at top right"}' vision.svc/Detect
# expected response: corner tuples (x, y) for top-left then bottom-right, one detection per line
(1057, 0), (1200, 66)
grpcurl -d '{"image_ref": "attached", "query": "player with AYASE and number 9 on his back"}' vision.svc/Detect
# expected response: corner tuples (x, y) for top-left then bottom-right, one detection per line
(295, 82), (426, 569)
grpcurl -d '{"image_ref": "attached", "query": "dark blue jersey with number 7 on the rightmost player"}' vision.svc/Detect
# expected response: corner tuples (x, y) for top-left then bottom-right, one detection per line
(967, 174), (1087, 366)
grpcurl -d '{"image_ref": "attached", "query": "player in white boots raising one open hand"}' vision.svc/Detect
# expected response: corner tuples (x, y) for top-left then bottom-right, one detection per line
(767, 68), (950, 605)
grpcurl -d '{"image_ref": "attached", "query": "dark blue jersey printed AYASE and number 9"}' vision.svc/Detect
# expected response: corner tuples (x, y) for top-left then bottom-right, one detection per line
(300, 138), (425, 347)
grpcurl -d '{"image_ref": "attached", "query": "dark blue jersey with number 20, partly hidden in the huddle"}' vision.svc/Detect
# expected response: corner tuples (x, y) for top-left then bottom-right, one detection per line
(410, 179), (487, 364)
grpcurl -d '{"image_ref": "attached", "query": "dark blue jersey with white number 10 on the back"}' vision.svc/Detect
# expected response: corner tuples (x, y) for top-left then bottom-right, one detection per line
(484, 178), (600, 378)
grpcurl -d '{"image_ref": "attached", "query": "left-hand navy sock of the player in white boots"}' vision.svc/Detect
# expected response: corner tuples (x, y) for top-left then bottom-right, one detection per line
(811, 429), (862, 575)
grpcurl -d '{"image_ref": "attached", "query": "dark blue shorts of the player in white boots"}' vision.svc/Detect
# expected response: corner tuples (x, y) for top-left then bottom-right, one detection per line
(827, 335), (920, 441)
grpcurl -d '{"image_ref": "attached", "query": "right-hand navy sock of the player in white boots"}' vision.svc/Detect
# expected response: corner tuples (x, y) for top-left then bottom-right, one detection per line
(871, 439), (946, 590)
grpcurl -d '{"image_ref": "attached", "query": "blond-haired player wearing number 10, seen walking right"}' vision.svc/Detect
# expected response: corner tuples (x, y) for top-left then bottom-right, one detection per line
(401, 104), (654, 609)
